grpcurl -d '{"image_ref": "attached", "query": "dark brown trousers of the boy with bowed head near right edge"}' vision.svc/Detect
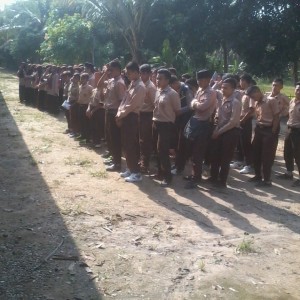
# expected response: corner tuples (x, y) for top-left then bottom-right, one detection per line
(252, 125), (278, 181)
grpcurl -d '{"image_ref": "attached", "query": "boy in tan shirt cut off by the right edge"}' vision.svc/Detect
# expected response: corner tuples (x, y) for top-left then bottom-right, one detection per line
(277, 82), (300, 187)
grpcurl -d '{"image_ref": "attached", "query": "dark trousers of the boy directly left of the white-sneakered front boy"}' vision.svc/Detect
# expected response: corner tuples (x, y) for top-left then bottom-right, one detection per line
(106, 109), (122, 165)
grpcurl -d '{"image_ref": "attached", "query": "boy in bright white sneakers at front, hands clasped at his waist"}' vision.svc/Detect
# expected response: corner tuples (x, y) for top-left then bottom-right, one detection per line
(116, 62), (146, 182)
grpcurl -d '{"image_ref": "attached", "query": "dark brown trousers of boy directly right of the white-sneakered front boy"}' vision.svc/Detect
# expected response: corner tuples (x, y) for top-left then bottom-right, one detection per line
(139, 112), (153, 168)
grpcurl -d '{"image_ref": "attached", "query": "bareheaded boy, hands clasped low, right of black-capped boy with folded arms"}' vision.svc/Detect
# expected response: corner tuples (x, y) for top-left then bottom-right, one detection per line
(208, 78), (242, 188)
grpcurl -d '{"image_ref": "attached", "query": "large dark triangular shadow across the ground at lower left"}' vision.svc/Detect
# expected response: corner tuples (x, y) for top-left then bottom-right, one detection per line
(0, 94), (102, 300)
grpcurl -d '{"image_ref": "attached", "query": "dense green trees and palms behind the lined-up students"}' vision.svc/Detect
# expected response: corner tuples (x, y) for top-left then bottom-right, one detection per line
(0, 0), (300, 80)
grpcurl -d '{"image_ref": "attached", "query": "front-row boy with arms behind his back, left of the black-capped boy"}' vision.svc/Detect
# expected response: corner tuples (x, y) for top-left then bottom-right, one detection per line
(153, 69), (181, 187)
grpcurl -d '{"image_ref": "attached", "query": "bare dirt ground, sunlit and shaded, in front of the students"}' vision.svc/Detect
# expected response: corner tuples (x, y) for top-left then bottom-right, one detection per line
(0, 70), (300, 300)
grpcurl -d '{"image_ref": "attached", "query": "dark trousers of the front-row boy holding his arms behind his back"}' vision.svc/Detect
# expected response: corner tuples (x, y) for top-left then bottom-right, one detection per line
(153, 121), (174, 182)
